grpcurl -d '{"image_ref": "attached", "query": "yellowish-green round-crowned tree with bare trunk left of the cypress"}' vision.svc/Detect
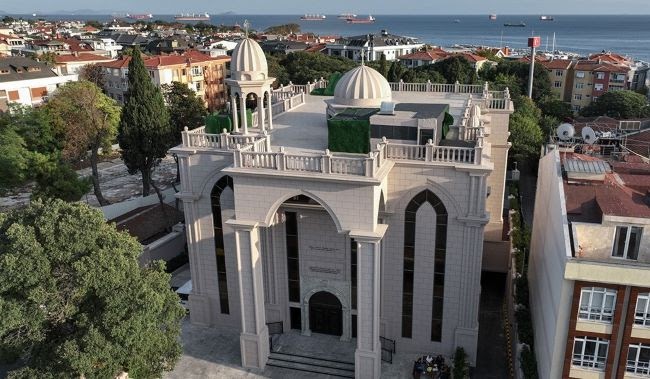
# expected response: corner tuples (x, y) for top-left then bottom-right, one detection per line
(47, 80), (120, 206)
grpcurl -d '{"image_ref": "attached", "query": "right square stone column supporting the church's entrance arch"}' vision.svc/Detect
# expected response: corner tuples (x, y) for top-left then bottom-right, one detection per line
(350, 225), (386, 379)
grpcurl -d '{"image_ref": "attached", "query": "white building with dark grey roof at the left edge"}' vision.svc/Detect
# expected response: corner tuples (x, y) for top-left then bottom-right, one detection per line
(0, 57), (77, 110)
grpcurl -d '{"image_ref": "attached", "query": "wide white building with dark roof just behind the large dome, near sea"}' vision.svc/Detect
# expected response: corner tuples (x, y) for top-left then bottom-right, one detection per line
(325, 30), (424, 62)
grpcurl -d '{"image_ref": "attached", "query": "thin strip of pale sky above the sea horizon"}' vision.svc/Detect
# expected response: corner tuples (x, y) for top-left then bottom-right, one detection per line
(0, 0), (650, 15)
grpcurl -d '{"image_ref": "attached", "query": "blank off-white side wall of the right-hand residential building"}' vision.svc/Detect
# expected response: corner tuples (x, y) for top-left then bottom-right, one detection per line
(528, 150), (573, 378)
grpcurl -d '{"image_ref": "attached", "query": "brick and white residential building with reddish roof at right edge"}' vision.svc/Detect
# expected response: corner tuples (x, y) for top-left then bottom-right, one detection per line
(528, 146), (650, 379)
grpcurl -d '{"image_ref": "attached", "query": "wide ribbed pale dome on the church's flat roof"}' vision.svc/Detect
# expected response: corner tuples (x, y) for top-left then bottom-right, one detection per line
(334, 65), (392, 108)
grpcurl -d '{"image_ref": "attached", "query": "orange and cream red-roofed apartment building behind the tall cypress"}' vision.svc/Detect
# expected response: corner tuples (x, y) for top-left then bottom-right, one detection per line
(100, 50), (230, 111)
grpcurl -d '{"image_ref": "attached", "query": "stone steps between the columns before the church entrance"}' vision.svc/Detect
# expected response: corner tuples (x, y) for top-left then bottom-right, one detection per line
(267, 352), (354, 378)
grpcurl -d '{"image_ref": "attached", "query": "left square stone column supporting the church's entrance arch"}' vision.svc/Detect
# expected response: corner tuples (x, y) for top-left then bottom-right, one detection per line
(226, 219), (269, 369)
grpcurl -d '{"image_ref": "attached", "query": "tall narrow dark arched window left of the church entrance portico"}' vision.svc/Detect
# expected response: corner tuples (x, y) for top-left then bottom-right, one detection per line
(210, 175), (233, 314)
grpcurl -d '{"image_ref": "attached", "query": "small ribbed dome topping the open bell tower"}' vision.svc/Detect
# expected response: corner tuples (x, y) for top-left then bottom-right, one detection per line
(230, 38), (269, 80)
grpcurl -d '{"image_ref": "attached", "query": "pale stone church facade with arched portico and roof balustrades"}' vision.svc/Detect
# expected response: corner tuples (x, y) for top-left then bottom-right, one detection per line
(173, 37), (512, 378)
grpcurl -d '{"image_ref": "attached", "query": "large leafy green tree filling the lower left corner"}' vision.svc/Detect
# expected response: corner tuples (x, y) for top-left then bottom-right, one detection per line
(0, 200), (184, 379)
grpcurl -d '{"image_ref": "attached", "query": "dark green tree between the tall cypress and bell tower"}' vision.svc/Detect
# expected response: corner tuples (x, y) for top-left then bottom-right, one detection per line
(161, 82), (208, 147)
